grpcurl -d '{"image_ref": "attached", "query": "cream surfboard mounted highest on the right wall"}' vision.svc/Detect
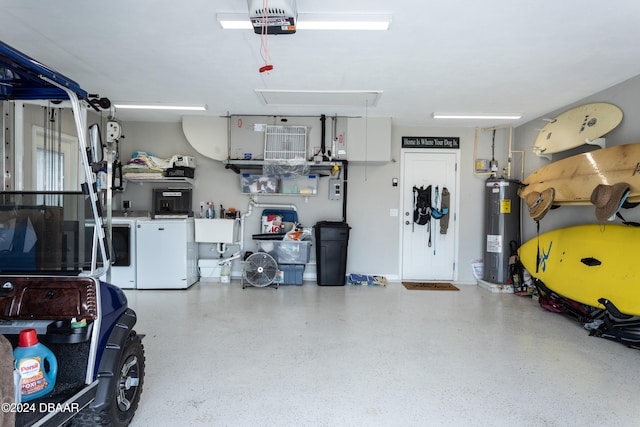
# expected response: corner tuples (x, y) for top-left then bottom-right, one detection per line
(533, 102), (622, 156)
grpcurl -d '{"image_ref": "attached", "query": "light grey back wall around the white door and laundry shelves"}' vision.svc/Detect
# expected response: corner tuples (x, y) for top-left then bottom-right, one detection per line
(114, 118), (506, 283)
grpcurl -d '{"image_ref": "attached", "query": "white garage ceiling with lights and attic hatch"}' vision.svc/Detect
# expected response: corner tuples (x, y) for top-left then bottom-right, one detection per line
(0, 0), (640, 126)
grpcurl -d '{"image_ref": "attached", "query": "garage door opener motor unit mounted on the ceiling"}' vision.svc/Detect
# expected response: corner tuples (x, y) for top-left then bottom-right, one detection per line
(247, 0), (298, 34)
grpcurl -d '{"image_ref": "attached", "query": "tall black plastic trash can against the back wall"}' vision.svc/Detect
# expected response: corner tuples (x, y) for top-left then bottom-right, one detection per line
(314, 221), (351, 286)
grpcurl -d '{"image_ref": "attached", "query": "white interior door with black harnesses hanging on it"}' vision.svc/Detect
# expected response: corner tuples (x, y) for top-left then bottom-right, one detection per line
(402, 149), (459, 281)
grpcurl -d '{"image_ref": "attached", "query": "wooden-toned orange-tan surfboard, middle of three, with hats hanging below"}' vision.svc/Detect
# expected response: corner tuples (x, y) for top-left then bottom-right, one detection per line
(518, 143), (640, 205)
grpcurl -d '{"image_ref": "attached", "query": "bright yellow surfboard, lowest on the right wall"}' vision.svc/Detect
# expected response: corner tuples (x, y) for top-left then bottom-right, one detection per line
(518, 224), (640, 316)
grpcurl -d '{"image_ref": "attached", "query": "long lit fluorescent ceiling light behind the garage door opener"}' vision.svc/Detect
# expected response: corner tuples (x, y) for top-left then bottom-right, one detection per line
(217, 13), (391, 31)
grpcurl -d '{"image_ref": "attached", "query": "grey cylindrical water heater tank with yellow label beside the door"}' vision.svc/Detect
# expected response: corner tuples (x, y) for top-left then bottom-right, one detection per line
(483, 177), (520, 284)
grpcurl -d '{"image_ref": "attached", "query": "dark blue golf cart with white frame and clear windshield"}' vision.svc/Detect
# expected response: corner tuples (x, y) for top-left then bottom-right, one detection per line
(0, 42), (145, 426)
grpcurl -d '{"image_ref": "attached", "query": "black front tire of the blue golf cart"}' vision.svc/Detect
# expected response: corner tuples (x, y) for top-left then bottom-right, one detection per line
(72, 331), (145, 427)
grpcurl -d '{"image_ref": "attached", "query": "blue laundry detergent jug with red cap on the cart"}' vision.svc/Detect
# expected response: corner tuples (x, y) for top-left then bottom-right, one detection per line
(13, 329), (58, 402)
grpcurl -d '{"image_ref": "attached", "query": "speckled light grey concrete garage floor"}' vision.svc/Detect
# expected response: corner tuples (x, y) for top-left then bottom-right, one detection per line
(126, 281), (640, 427)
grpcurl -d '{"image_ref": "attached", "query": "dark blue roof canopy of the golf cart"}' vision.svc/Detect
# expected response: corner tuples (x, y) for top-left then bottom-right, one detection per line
(0, 41), (87, 100)
